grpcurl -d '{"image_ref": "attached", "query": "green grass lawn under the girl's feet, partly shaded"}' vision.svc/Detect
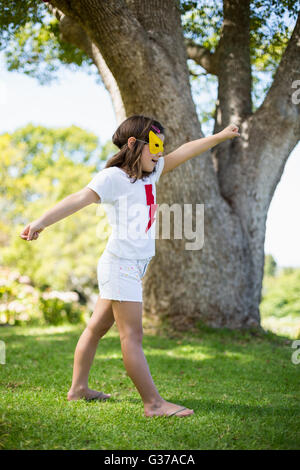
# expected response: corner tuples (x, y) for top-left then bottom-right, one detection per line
(0, 325), (300, 450)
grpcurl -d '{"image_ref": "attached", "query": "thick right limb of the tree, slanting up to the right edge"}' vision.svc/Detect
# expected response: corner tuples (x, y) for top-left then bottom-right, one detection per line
(227, 13), (300, 209)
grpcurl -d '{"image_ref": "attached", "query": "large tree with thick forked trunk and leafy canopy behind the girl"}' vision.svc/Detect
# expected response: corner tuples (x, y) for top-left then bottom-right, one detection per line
(2, 0), (300, 328)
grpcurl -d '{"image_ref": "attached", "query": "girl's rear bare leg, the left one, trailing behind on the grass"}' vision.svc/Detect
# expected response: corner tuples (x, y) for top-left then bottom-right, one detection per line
(68, 297), (115, 400)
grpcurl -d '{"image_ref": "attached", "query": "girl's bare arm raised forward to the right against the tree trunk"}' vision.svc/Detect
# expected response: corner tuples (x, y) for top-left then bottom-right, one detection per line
(162, 124), (240, 175)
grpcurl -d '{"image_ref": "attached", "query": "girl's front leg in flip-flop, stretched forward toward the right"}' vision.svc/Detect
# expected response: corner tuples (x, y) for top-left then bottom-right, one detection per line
(112, 300), (193, 416)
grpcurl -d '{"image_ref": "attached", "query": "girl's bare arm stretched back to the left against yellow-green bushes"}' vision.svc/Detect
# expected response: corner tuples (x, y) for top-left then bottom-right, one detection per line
(20, 188), (99, 241)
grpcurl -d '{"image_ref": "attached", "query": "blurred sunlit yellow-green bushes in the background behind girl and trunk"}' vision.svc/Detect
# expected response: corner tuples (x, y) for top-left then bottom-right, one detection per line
(0, 124), (300, 339)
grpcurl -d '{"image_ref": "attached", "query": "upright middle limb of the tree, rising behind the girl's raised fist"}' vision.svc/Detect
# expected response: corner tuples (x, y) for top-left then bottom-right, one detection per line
(212, 0), (252, 196)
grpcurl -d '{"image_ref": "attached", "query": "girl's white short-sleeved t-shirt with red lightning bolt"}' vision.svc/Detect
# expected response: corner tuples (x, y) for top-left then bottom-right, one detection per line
(86, 157), (165, 259)
